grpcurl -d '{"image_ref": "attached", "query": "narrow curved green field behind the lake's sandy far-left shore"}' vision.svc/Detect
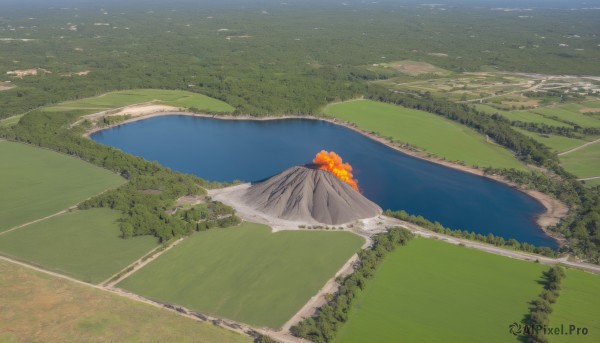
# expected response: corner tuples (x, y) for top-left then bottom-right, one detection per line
(44, 89), (235, 113)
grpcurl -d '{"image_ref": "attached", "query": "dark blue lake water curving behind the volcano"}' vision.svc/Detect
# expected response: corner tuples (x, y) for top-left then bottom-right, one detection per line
(91, 116), (556, 247)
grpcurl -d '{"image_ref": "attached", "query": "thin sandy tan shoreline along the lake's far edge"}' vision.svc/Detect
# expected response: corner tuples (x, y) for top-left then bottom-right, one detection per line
(83, 109), (569, 247)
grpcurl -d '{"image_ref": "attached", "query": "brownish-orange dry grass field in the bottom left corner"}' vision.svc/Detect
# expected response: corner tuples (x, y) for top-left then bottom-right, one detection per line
(0, 260), (251, 343)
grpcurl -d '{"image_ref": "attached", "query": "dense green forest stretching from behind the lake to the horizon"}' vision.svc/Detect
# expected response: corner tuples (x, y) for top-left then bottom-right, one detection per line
(0, 2), (600, 118)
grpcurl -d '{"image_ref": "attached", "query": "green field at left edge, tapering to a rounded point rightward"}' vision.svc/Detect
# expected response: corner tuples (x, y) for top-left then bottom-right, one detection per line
(0, 141), (125, 232)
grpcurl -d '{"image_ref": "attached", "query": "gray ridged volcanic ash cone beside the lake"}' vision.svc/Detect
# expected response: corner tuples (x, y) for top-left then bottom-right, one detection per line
(242, 166), (382, 225)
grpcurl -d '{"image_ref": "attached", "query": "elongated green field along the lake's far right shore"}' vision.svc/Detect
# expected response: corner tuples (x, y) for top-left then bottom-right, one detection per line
(324, 100), (524, 169)
